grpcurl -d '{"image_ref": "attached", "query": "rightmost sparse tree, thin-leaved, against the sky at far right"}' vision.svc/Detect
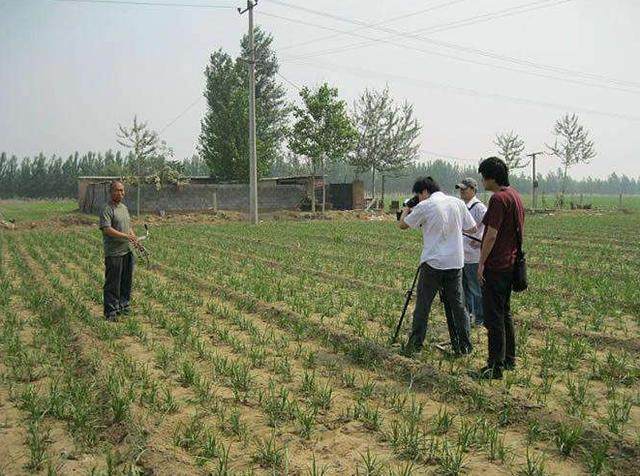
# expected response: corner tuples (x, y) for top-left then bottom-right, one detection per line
(547, 114), (596, 201)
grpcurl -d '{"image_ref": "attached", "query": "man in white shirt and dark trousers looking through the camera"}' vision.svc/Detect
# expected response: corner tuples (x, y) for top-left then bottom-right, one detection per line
(398, 177), (477, 354)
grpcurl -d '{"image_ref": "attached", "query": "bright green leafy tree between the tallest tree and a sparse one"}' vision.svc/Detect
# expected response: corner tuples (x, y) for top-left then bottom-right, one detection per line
(289, 83), (358, 213)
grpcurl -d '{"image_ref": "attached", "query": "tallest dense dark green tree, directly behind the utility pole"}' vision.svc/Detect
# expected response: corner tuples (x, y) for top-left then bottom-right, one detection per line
(199, 27), (290, 181)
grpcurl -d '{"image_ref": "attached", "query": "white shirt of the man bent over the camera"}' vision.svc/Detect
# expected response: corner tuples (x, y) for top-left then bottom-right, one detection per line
(404, 192), (476, 269)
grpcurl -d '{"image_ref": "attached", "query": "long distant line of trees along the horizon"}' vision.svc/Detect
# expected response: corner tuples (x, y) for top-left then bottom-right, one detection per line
(0, 151), (640, 198)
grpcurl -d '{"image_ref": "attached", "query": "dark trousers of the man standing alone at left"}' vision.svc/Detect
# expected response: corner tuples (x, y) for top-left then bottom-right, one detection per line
(104, 253), (135, 316)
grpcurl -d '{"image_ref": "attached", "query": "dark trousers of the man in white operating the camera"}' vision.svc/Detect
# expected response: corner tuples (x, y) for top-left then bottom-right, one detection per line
(408, 263), (472, 353)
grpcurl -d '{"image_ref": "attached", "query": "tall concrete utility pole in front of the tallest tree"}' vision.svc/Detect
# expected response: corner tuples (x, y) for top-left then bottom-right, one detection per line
(238, 0), (258, 225)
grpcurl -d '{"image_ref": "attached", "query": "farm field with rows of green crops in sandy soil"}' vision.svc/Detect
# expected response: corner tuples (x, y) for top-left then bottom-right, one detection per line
(0, 207), (640, 476)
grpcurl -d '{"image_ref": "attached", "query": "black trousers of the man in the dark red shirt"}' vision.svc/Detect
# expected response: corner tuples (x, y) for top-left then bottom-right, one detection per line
(482, 269), (516, 367)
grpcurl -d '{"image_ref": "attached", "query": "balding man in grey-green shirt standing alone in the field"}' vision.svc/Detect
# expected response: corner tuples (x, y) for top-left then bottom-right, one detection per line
(100, 182), (138, 322)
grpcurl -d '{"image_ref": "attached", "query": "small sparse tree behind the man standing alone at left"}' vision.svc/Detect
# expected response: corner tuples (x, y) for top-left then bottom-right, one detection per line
(117, 116), (162, 216)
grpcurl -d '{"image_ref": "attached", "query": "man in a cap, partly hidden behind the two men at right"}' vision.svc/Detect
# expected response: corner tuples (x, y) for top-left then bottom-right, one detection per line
(456, 178), (487, 326)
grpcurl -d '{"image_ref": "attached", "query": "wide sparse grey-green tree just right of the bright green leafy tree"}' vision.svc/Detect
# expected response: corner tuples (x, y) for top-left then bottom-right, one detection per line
(351, 87), (421, 203)
